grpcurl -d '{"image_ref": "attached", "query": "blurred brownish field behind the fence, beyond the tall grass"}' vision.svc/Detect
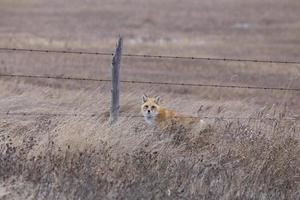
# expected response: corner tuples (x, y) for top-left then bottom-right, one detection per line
(0, 0), (300, 115)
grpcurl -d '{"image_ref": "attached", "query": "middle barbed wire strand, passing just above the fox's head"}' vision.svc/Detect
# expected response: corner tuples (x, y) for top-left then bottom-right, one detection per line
(0, 74), (300, 91)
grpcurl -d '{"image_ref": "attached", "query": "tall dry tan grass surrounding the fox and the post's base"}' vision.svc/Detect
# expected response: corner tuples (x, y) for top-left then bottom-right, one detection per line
(0, 81), (300, 199)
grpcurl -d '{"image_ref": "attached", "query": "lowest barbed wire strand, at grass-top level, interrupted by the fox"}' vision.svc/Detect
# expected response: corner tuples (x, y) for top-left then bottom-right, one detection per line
(0, 111), (300, 121)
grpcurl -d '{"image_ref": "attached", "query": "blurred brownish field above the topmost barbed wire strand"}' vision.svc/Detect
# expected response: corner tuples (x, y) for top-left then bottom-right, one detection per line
(0, 0), (300, 60)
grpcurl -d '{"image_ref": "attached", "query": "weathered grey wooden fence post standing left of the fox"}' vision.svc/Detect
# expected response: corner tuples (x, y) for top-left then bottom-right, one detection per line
(110, 36), (123, 123)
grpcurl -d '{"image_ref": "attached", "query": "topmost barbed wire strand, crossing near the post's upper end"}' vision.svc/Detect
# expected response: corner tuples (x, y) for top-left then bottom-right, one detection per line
(0, 47), (300, 65)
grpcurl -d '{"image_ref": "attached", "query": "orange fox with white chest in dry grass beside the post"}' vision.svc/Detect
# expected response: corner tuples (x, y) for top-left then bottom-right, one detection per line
(141, 94), (206, 128)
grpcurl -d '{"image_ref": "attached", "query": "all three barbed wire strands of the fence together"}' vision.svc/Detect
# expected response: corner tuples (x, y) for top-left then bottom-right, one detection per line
(0, 38), (300, 121)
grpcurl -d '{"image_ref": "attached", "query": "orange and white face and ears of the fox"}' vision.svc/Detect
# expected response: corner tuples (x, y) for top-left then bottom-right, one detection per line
(141, 94), (160, 123)
